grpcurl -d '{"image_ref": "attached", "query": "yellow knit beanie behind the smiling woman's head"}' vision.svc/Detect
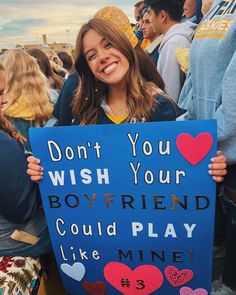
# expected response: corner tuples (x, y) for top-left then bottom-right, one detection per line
(94, 6), (138, 48)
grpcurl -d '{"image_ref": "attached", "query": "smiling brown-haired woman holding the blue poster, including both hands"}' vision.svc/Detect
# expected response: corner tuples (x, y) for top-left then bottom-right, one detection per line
(28, 18), (226, 181)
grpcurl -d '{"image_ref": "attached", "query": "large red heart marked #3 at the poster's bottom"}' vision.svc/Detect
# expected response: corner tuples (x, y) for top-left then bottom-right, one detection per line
(104, 262), (164, 295)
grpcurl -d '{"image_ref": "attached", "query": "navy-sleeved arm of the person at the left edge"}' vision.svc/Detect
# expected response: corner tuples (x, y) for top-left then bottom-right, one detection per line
(0, 132), (41, 223)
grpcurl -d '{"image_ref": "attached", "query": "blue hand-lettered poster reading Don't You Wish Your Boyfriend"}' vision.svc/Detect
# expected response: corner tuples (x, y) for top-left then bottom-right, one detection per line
(30, 121), (216, 295)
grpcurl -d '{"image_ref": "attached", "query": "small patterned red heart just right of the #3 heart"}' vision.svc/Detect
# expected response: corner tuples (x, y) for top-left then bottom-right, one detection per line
(165, 266), (193, 287)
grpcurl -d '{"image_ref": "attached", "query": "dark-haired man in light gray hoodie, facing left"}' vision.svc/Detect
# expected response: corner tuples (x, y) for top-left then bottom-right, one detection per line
(145, 0), (196, 102)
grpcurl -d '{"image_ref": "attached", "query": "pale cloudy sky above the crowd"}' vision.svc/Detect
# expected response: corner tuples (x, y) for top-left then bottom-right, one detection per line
(0, 0), (138, 49)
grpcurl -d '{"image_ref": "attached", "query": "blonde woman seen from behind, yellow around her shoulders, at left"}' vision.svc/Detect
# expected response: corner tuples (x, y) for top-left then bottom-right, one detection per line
(4, 49), (53, 151)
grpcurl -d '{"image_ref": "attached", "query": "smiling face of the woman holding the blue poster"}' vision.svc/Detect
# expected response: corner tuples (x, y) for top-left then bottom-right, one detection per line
(83, 29), (129, 86)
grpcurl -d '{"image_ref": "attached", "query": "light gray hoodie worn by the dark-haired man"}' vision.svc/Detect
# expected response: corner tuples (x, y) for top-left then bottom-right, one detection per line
(157, 22), (197, 102)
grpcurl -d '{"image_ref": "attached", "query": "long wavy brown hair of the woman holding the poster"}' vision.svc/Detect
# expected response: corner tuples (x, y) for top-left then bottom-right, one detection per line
(72, 18), (156, 125)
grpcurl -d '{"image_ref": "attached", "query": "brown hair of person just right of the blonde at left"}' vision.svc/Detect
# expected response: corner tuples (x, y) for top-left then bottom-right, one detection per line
(27, 48), (64, 93)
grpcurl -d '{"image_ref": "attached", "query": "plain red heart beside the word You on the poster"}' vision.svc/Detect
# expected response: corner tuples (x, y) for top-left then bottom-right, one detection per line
(176, 132), (213, 165)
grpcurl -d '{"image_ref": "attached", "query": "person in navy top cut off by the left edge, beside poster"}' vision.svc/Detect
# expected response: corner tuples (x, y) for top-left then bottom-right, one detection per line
(0, 64), (50, 260)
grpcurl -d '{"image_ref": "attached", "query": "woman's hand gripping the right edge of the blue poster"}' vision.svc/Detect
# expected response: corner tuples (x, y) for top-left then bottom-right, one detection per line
(208, 151), (227, 182)
